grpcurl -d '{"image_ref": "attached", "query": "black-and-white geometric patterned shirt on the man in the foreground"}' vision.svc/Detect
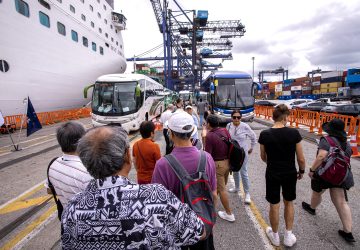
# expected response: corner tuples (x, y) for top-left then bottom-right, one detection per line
(62, 176), (203, 249)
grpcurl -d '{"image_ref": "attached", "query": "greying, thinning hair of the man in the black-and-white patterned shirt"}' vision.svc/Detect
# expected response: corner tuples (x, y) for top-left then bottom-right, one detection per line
(78, 126), (129, 179)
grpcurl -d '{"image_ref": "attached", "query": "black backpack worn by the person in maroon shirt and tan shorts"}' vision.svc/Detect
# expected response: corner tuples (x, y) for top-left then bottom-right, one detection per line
(215, 129), (246, 172)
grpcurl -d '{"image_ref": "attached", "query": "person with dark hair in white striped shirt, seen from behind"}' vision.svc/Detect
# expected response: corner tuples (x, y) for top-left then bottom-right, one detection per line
(45, 121), (92, 219)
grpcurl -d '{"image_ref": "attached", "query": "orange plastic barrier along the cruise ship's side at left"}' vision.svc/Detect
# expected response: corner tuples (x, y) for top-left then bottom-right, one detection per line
(4, 108), (91, 129)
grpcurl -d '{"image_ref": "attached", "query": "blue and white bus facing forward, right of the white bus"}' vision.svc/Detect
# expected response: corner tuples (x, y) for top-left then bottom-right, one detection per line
(202, 71), (258, 124)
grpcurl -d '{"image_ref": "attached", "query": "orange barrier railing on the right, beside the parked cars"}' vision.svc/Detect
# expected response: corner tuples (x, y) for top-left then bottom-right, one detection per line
(255, 105), (360, 145)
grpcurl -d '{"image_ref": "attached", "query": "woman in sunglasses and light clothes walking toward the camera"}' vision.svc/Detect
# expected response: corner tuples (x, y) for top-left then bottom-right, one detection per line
(226, 110), (256, 204)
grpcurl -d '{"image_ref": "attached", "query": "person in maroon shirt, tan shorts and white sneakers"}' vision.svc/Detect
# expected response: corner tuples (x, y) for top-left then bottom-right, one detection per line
(205, 115), (235, 222)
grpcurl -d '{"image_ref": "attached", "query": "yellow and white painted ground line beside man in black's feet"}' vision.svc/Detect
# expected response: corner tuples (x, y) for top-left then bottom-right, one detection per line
(228, 177), (281, 250)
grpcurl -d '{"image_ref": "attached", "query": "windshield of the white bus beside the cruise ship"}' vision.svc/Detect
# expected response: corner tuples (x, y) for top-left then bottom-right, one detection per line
(92, 81), (137, 115)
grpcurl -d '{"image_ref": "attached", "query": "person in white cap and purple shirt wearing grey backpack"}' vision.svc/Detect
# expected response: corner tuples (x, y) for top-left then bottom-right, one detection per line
(152, 112), (217, 250)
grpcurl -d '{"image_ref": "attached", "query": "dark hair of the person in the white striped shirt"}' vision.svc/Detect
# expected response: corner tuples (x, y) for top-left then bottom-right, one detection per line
(56, 122), (86, 153)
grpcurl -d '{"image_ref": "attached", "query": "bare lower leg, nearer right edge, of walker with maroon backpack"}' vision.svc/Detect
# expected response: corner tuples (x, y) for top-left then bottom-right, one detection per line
(330, 188), (352, 233)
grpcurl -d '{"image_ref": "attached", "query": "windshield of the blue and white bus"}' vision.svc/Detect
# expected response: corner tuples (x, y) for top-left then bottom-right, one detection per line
(215, 79), (254, 108)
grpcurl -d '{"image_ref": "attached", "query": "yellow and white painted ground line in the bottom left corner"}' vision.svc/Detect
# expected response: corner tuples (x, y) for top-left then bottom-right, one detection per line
(2, 205), (57, 250)
